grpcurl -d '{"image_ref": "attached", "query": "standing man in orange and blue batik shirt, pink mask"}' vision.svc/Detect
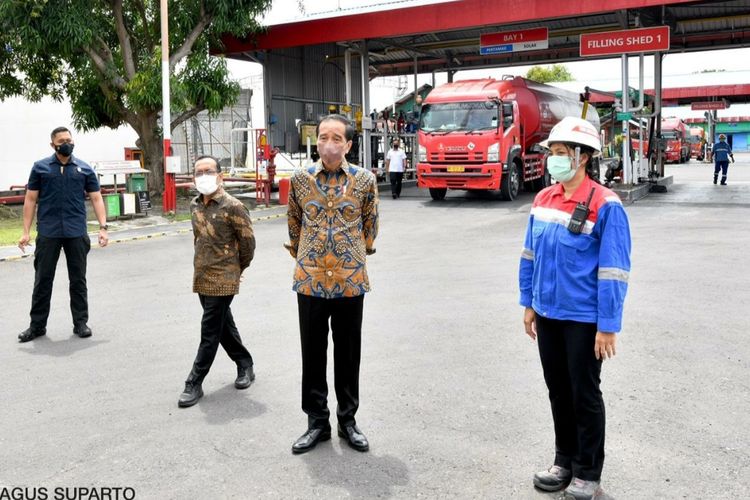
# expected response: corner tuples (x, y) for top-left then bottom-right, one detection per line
(285, 115), (378, 453)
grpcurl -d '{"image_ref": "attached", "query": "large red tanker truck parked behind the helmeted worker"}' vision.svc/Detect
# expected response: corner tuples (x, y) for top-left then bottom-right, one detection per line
(417, 77), (599, 200)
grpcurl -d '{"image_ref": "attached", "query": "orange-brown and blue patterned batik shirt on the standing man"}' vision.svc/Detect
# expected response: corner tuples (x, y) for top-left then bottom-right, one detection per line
(285, 162), (378, 299)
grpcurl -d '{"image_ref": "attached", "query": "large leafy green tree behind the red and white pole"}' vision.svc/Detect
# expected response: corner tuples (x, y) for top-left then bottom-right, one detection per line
(0, 0), (271, 191)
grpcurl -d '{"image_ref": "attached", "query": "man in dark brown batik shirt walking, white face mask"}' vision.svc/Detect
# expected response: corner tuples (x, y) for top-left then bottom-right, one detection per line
(177, 156), (255, 408)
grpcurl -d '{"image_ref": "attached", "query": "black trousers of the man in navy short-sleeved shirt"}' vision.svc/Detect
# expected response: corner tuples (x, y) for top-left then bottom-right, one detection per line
(29, 235), (91, 330)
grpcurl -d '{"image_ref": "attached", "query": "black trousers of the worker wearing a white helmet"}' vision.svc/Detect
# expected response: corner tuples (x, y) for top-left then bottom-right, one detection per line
(536, 315), (605, 481)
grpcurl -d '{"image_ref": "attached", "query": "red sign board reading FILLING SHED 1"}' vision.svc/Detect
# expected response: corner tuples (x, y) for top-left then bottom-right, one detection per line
(580, 26), (669, 57)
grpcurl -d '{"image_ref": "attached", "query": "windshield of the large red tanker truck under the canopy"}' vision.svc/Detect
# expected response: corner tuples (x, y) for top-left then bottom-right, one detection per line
(419, 101), (497, 132)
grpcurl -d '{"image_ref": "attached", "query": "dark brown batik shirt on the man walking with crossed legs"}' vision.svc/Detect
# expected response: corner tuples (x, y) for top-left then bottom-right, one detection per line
(190, 187), (255, 296)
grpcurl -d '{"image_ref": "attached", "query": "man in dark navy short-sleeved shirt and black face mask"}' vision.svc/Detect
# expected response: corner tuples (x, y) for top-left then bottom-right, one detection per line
(18, 127), (109, 342)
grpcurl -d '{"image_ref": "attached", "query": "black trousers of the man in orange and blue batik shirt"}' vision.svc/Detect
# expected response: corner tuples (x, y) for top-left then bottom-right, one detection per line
(297, 294), (364, 429)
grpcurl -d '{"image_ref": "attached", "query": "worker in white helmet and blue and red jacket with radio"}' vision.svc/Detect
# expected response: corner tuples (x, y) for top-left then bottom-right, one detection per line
(519, 117), (630, 499)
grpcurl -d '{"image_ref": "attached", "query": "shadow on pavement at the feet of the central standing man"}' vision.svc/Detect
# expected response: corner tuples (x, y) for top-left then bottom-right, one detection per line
(301, 444), (409, 498)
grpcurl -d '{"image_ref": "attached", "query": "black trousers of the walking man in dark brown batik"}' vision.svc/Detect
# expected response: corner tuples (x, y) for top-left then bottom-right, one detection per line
(188, 294), (253, 384)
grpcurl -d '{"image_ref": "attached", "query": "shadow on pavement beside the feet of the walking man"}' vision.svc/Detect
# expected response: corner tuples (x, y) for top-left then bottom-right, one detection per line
(197, 384), (267, 425)
